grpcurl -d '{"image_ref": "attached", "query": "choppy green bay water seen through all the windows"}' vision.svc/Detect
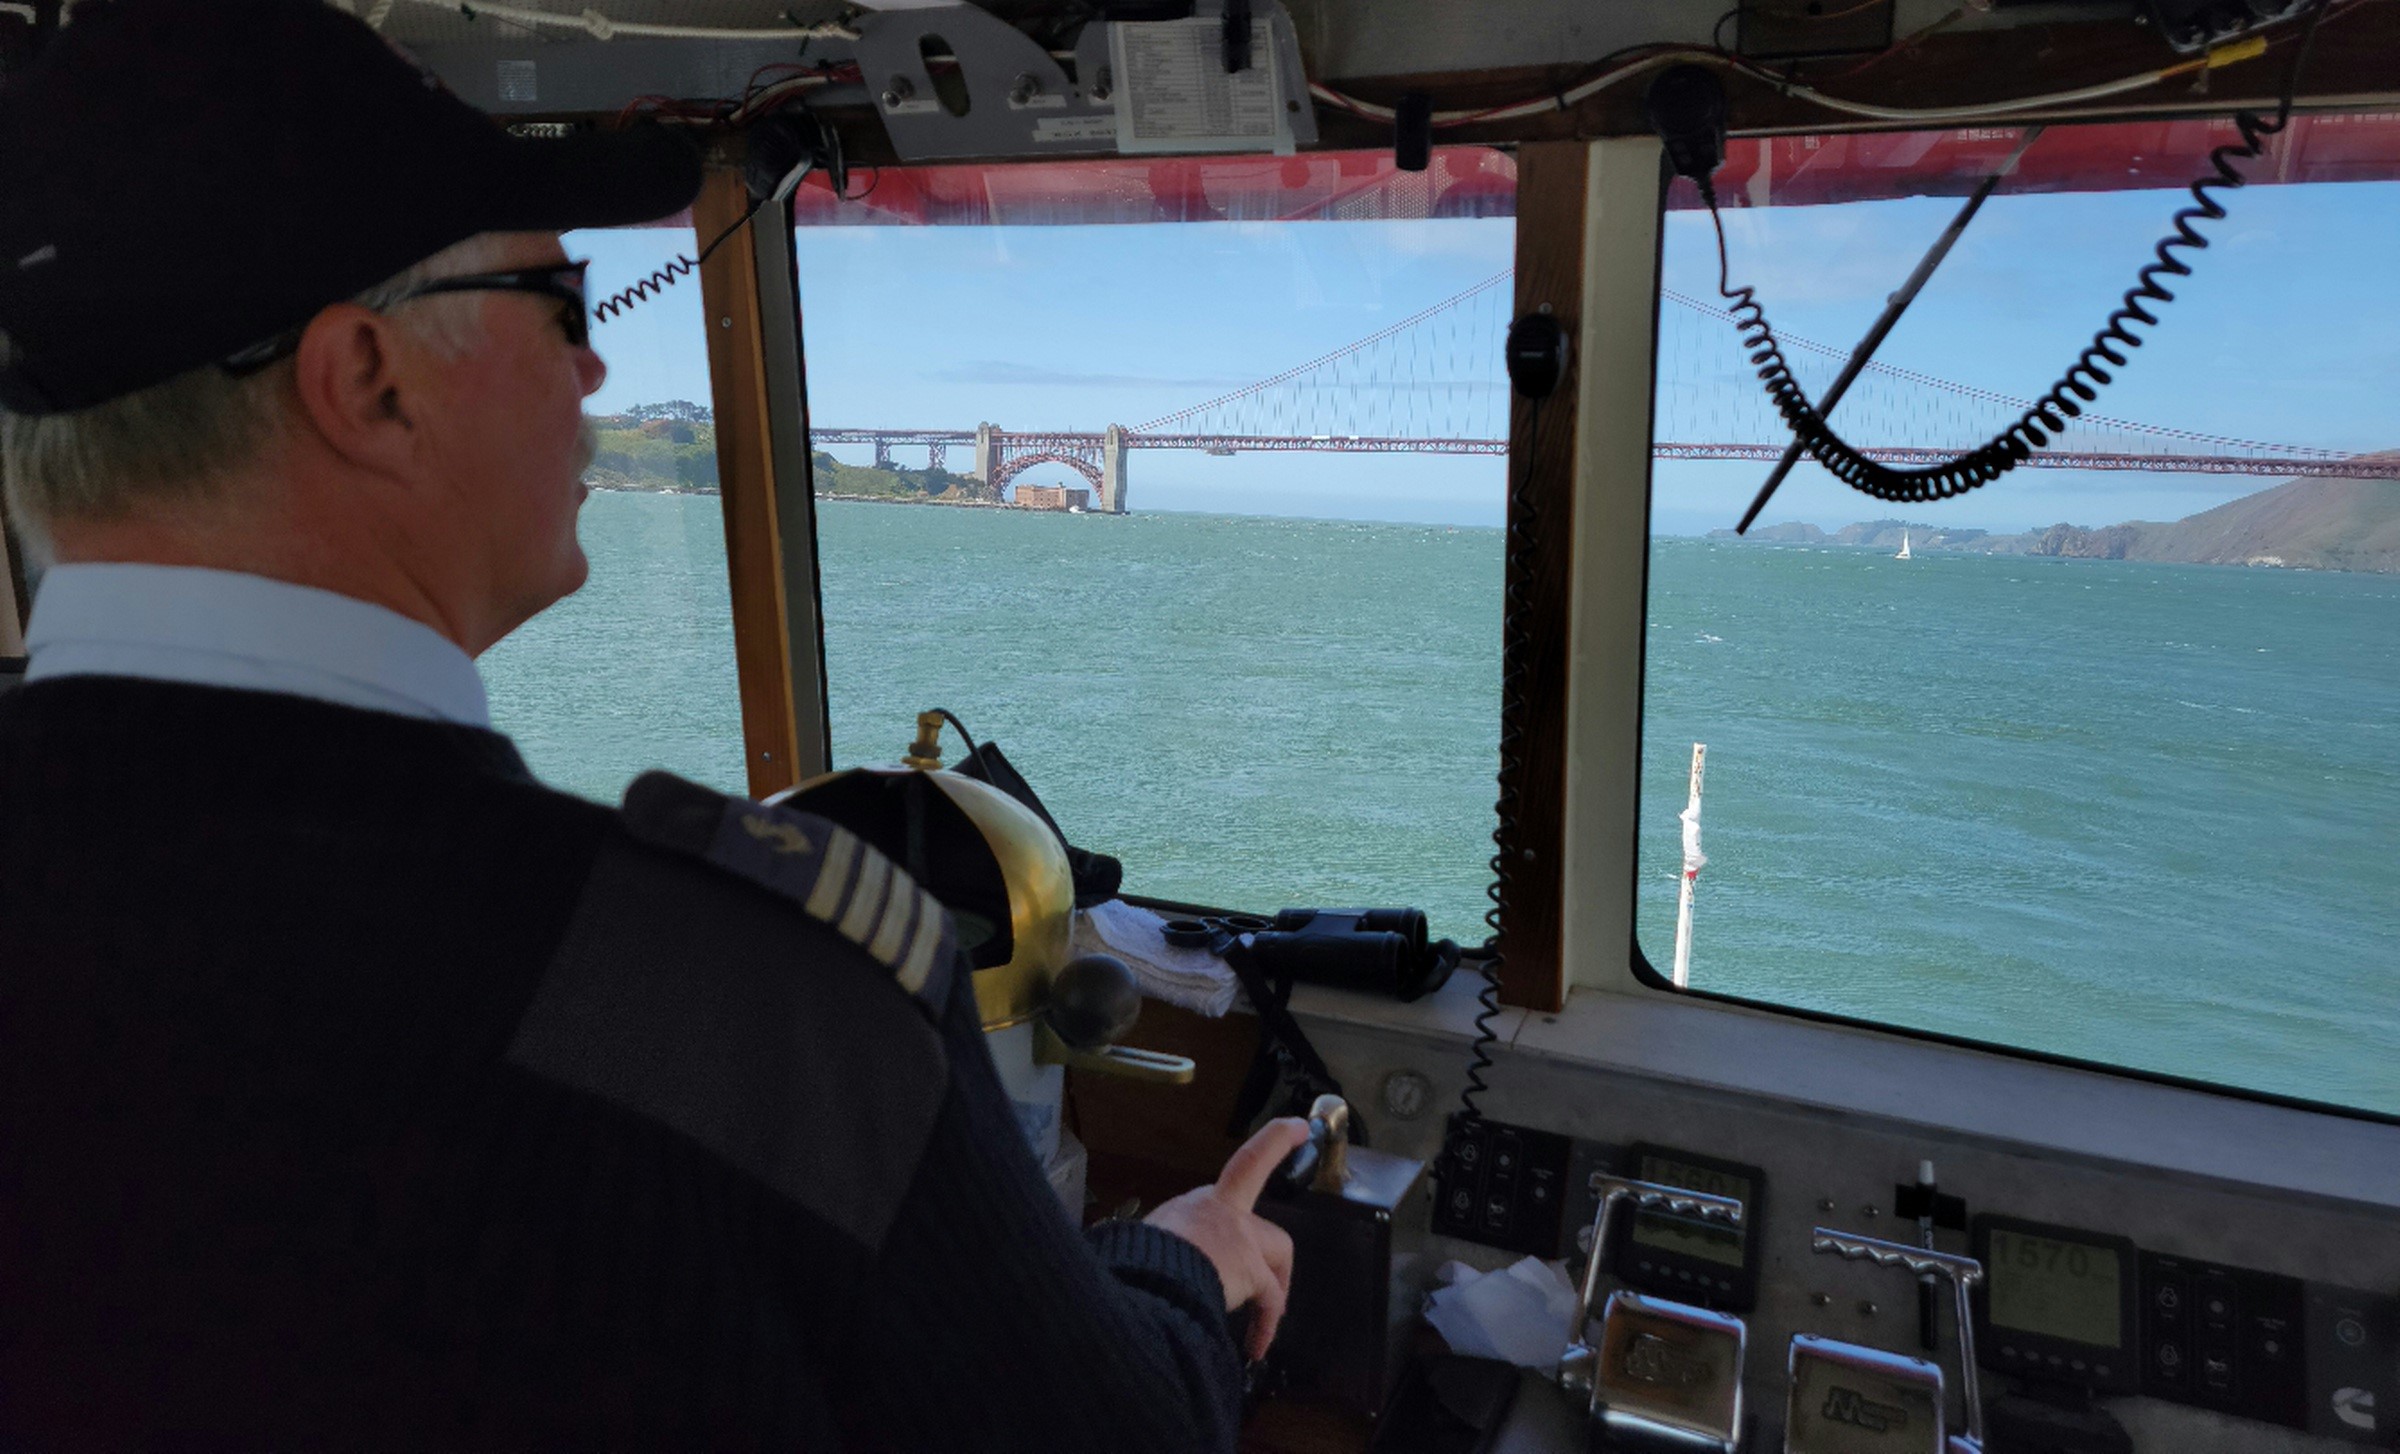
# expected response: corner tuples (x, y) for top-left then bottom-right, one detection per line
(485, 494), (2400, 1113)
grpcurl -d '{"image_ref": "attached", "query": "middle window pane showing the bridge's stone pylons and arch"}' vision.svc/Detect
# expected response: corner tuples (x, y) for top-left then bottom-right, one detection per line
(794, 151), (1514, 943)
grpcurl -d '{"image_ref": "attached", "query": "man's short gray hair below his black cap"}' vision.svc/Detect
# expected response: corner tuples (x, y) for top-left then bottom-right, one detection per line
(0, 233), (518, 564)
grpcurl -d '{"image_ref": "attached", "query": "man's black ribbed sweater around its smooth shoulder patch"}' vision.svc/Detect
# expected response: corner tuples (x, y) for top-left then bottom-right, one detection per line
(0, 679), (1241, 1454)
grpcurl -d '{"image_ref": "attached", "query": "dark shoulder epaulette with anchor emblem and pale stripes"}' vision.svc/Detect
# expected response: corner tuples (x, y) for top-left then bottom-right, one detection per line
(624, 773), (958, 1017)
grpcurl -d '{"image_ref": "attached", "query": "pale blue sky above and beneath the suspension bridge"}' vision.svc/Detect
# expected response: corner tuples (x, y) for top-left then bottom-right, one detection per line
(571, 182), (2400, 535)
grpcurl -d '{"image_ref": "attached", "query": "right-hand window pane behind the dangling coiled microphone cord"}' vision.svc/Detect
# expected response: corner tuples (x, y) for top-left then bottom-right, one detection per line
(1637, 115), (2400, 1113)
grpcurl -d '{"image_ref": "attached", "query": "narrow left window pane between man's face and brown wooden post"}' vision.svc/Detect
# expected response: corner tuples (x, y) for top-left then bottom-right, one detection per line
(480, 226), (746, 801)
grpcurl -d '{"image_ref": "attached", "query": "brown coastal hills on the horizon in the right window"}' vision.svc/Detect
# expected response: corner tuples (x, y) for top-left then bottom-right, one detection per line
(1709, 467), (2400, 573)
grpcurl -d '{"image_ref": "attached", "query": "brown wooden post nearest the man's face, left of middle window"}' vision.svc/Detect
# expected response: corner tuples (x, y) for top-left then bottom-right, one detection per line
(691, 168), (799, 797)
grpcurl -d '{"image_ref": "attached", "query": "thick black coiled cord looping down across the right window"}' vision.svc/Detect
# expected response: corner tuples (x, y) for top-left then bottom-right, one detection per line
(1694, 2), (2326, 504)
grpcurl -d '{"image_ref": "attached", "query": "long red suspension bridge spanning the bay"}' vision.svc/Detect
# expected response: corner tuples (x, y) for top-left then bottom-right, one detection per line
(809, 271), (2400, 511)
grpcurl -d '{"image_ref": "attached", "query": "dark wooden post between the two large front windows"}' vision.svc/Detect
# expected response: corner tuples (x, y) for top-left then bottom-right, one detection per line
(1498, 142), (1589, 1010)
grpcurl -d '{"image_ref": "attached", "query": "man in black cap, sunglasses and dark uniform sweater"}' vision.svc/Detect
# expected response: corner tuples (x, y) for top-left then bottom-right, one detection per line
(0, 0), (1303, 1454)
